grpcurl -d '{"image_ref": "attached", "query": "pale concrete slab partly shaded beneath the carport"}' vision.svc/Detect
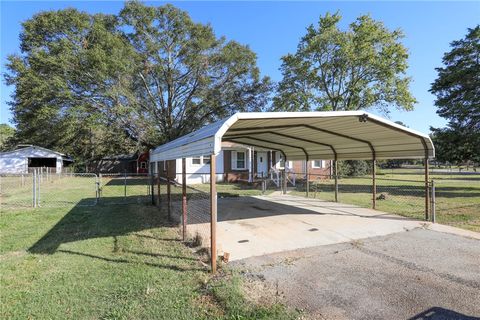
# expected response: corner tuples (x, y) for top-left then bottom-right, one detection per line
(217, 195), (424, 261)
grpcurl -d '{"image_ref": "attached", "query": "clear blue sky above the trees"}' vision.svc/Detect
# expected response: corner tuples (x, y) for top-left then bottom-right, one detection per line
(0, 0), (480, 133)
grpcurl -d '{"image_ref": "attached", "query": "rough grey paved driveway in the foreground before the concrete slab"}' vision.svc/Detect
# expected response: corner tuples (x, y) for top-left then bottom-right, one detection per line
(233, 229), (480, 320)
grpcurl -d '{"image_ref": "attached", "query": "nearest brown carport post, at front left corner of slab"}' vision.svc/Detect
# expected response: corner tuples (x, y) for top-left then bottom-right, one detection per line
(210, 154), (217, 273)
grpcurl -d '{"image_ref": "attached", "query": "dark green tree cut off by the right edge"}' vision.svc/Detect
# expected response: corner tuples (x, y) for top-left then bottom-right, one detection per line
(430, 25), (480, 163)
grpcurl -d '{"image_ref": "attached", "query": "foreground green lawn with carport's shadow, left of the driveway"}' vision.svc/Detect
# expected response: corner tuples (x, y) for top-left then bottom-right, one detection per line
(0, 204), (296, 319)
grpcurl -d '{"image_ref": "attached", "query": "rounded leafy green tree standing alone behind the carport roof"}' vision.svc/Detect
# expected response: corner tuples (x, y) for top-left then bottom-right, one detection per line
(273, 13), (416, 114)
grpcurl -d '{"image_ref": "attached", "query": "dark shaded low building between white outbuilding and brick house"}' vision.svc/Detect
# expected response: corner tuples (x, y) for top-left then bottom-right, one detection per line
(89, 152), (149, 173)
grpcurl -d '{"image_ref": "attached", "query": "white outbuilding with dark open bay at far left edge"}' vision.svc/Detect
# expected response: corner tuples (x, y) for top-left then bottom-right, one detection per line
(0, 146), (73, 173)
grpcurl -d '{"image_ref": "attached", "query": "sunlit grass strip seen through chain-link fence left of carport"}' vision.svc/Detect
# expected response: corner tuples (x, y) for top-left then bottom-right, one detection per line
(0, 170), (151, 210)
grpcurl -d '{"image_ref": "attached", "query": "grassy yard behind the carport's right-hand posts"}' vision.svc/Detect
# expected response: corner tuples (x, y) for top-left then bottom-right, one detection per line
(291, 169), (480, 232)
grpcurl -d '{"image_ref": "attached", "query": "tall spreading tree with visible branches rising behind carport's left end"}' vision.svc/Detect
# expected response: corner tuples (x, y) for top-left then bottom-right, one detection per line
(120, 2), (271, 143)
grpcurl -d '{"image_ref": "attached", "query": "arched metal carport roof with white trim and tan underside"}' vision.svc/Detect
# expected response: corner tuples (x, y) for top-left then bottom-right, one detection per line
(150, 111), (435, 161)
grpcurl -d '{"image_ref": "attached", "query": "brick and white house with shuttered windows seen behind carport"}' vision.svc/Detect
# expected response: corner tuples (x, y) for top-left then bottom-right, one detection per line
(150, 142), (330, 184)
